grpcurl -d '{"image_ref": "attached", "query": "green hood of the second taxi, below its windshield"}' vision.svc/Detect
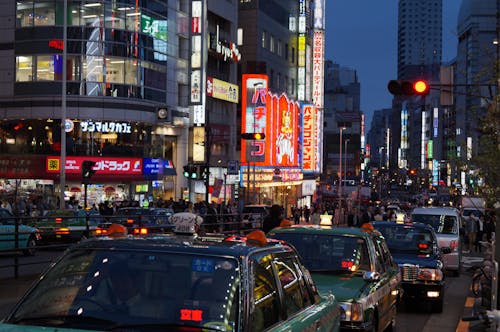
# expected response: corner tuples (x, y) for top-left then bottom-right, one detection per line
(311, 271), (370, 302)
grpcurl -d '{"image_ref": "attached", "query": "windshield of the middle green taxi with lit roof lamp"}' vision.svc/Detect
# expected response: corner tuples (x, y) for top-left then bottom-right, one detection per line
(273, 233), (371, 274)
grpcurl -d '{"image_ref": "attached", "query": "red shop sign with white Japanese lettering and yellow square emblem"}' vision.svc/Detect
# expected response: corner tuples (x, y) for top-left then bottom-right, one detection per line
(46, 156), (142, 175)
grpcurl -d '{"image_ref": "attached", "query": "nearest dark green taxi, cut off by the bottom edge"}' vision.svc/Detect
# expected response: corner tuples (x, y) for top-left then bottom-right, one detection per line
(0, 213), (340, 332)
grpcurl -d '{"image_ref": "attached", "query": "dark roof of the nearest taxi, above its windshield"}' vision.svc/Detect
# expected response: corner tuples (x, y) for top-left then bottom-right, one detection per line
(72, 234), (294, 259)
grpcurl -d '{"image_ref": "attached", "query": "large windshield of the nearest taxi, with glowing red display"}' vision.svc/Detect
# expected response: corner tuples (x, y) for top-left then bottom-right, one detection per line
(9, 249), (242, 331)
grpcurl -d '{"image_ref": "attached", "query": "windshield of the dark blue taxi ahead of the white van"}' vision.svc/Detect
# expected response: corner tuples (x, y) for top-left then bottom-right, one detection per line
(376, 225), (434, 255)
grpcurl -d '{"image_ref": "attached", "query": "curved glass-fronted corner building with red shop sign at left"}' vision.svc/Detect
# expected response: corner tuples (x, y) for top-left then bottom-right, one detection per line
(0, 0), (189, 208)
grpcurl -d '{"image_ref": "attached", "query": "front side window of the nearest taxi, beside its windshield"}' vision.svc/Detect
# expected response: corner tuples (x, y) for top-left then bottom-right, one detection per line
(250, 254), (280, 331)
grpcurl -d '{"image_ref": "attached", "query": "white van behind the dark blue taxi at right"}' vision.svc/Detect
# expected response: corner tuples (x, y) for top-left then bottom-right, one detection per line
(411, 207), (462, 276)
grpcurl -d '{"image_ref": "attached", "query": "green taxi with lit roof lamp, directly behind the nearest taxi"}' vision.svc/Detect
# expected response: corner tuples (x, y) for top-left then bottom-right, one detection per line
(267, 224), (402, 331)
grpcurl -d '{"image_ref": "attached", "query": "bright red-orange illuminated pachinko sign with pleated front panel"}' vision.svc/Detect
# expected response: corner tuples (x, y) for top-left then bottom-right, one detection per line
(241, 74), (299, 167)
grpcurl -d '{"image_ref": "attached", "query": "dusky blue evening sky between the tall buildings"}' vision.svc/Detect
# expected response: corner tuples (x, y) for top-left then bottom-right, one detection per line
(325, 0), (462, 128)
